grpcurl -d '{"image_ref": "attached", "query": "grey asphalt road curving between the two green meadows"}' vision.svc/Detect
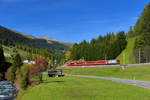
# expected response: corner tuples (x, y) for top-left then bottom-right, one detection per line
(67, 75), (150, 89)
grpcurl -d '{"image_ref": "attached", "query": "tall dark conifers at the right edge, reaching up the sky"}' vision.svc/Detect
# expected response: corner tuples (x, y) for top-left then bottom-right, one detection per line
(135, 3), (150, 48)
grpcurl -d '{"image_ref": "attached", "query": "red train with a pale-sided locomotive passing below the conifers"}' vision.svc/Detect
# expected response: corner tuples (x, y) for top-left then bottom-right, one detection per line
(67, 60), (120, 66)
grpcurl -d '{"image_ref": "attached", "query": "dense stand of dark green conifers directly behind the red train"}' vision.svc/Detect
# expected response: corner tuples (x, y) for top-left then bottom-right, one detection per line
(71, 31), (127, 61)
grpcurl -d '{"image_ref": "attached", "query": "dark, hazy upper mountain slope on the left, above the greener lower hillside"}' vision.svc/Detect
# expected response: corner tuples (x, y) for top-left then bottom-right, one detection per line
(0, 26), (73, 52)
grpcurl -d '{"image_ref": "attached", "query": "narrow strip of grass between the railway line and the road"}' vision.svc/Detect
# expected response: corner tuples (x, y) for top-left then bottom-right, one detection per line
(63, 66), (150, 81)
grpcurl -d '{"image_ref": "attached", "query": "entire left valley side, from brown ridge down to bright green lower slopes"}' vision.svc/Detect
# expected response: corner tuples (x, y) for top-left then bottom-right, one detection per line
(0, 26), (73, 64)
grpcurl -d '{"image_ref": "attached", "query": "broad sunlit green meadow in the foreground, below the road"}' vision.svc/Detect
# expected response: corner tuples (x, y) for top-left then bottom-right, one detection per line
(17, 75), (150, 100)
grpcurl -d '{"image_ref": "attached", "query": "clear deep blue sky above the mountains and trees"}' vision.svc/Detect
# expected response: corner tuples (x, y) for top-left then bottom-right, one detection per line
(0, 0), (150, 43)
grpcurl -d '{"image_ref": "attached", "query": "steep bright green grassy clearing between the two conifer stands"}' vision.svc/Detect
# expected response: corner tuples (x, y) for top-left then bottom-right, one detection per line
(116, 37), (136, 64)
